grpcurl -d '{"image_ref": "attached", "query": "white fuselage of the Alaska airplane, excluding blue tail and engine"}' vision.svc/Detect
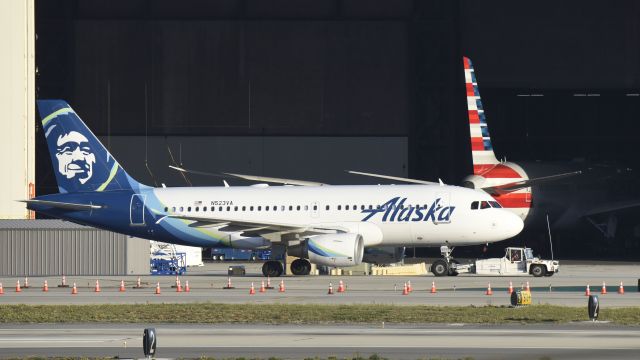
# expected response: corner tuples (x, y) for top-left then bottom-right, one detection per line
(147, 185), (523, 247)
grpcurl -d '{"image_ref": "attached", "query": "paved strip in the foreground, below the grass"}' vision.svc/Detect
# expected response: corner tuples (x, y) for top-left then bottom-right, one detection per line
(0, 322), (640, 359)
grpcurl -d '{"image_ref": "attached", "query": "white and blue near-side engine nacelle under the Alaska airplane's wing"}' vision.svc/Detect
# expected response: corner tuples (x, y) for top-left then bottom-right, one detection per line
(287, 233), (364, 266)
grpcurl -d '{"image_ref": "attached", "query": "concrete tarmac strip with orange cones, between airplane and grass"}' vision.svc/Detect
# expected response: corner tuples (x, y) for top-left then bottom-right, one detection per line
(0, 263), (640, 308)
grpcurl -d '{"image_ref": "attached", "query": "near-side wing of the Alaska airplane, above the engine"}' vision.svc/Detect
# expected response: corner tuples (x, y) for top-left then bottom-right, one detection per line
(156, 214), (346, 241)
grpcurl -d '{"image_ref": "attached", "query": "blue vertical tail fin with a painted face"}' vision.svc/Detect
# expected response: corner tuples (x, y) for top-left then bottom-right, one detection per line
(37, 100), (140, 193)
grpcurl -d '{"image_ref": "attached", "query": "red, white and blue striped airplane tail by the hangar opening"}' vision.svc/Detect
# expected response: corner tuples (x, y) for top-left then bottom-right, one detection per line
(463, 57), (531, 219)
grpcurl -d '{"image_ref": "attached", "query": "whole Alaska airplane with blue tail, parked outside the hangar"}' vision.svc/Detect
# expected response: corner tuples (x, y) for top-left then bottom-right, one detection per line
(25, 100), (523, 276)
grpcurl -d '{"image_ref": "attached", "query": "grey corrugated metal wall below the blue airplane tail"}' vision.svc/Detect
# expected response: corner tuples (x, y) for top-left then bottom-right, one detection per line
(0, 220), (149, 276)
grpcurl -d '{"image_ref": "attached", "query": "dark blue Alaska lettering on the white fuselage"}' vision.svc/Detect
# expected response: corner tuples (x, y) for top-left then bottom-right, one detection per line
(362, 197), (456, 222)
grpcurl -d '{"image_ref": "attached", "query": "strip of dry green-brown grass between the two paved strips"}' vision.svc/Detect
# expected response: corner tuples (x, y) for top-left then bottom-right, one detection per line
(0, 303), (640, 325)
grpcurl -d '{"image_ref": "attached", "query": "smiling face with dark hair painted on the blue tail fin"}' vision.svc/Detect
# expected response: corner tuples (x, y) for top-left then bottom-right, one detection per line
(56, 131), (96, 185)
